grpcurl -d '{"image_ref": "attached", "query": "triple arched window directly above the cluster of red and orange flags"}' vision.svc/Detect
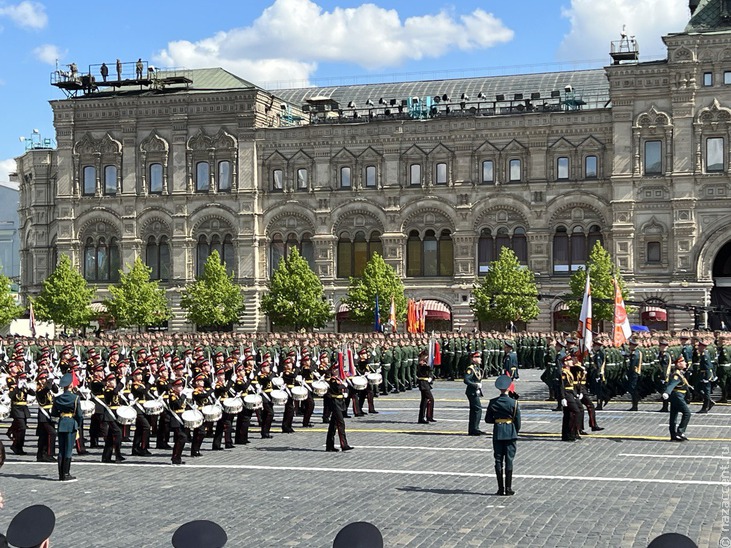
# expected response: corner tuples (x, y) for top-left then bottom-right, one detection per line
(406, 230), (454, 277)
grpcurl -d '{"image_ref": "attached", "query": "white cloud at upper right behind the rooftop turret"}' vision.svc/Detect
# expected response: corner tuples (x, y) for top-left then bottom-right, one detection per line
(558, 0), (690, 64)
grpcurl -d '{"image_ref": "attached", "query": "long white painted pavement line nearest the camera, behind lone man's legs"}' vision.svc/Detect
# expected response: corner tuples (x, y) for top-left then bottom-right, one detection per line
(5, 457), (728, 486)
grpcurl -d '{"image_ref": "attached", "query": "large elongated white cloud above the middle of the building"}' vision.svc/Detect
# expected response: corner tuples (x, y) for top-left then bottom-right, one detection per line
(156, 0), (513, 83)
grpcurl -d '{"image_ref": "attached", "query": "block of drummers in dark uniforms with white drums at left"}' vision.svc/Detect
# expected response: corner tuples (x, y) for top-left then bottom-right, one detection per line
(0, 344), (386, 464)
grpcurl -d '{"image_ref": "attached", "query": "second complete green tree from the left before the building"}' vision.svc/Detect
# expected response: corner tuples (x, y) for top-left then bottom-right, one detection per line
(104, 257), (172, 329)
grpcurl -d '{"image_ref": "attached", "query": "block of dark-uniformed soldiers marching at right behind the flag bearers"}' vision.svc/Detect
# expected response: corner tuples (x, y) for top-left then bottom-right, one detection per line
(541, 332), (731, 413)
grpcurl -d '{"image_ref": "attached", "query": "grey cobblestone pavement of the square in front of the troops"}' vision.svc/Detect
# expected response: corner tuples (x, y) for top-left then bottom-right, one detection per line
(0, 371), (731, 548)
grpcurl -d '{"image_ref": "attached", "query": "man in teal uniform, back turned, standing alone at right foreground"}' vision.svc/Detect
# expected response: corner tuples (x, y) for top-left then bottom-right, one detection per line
(485, 374), (520, 496)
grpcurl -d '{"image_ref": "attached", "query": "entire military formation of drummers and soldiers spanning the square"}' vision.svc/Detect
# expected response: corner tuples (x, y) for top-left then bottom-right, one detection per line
(0, 332), (731, 479)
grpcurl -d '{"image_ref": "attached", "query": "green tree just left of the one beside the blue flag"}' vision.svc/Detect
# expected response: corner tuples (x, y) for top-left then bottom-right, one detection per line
(261, 248), (332, 330)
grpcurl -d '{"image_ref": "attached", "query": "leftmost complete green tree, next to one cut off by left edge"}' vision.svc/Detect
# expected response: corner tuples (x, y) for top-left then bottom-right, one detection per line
(33, 255), (96, 329)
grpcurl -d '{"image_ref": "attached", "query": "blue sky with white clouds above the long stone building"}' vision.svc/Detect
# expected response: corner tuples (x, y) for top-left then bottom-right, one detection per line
(0, 0), (688, 182)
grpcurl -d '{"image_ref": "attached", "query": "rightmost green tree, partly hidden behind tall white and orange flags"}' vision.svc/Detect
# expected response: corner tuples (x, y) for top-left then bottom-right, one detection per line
(566, 242), (628, 325)
